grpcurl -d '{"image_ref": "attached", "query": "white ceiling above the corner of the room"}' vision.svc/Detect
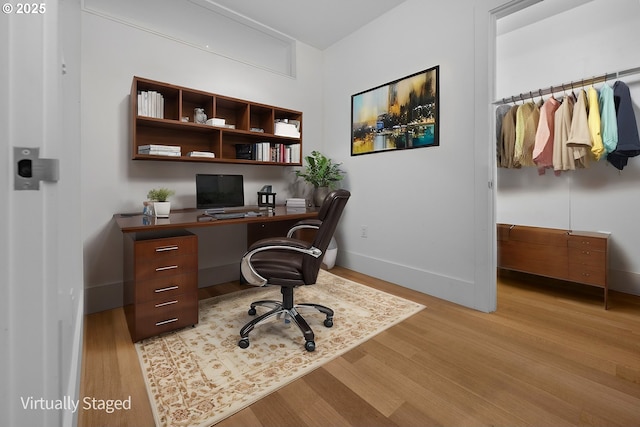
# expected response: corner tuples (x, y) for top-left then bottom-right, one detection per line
(200, 0), (405, 50)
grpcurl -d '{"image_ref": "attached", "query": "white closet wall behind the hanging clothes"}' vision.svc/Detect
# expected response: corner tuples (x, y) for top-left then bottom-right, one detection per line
(496, 0), (640, 294)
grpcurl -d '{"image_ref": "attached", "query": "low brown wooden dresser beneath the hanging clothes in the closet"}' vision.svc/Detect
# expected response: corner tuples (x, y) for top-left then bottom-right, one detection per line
(497, 224), (609, 309)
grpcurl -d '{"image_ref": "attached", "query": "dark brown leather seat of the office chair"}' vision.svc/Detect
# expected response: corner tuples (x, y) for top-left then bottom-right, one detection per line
(251, 251), (305, 286)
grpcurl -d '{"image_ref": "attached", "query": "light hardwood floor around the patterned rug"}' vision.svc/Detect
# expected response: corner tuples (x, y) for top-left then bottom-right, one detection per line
(79, 267), (640, 427)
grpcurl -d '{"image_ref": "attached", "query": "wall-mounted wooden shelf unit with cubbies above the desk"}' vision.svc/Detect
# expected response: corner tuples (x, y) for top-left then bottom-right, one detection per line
(131, 77), (302, 166)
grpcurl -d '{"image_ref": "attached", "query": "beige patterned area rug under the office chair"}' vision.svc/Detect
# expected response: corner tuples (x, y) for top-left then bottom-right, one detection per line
(136, 270), (424, 426)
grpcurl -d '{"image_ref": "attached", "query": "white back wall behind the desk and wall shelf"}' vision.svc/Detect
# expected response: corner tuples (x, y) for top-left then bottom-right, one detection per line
(82, 12), (323, 312)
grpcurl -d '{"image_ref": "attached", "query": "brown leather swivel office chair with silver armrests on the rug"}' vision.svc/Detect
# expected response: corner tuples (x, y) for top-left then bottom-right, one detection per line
(238, 190), (351, 351)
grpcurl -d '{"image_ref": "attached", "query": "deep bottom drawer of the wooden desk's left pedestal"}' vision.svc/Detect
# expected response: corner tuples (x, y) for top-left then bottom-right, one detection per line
(134, 292), (198, 341)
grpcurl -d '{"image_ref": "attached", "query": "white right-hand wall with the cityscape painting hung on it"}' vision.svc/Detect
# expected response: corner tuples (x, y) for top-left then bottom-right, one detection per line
(324, 0), (498, 310)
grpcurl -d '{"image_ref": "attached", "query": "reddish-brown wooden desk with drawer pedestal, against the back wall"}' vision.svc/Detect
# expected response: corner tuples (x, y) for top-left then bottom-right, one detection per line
(114, 206), (318, 342)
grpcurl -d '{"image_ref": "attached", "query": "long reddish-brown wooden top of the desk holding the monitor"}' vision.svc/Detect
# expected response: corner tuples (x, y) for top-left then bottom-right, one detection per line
(113, 206), (318, 233)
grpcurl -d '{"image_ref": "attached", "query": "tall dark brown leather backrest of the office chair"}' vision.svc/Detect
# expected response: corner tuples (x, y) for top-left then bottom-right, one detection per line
(302, 190), (351, 284)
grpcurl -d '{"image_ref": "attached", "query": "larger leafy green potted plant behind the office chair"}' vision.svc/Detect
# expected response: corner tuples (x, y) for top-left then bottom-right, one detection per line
(296, 150), (344, 206)
